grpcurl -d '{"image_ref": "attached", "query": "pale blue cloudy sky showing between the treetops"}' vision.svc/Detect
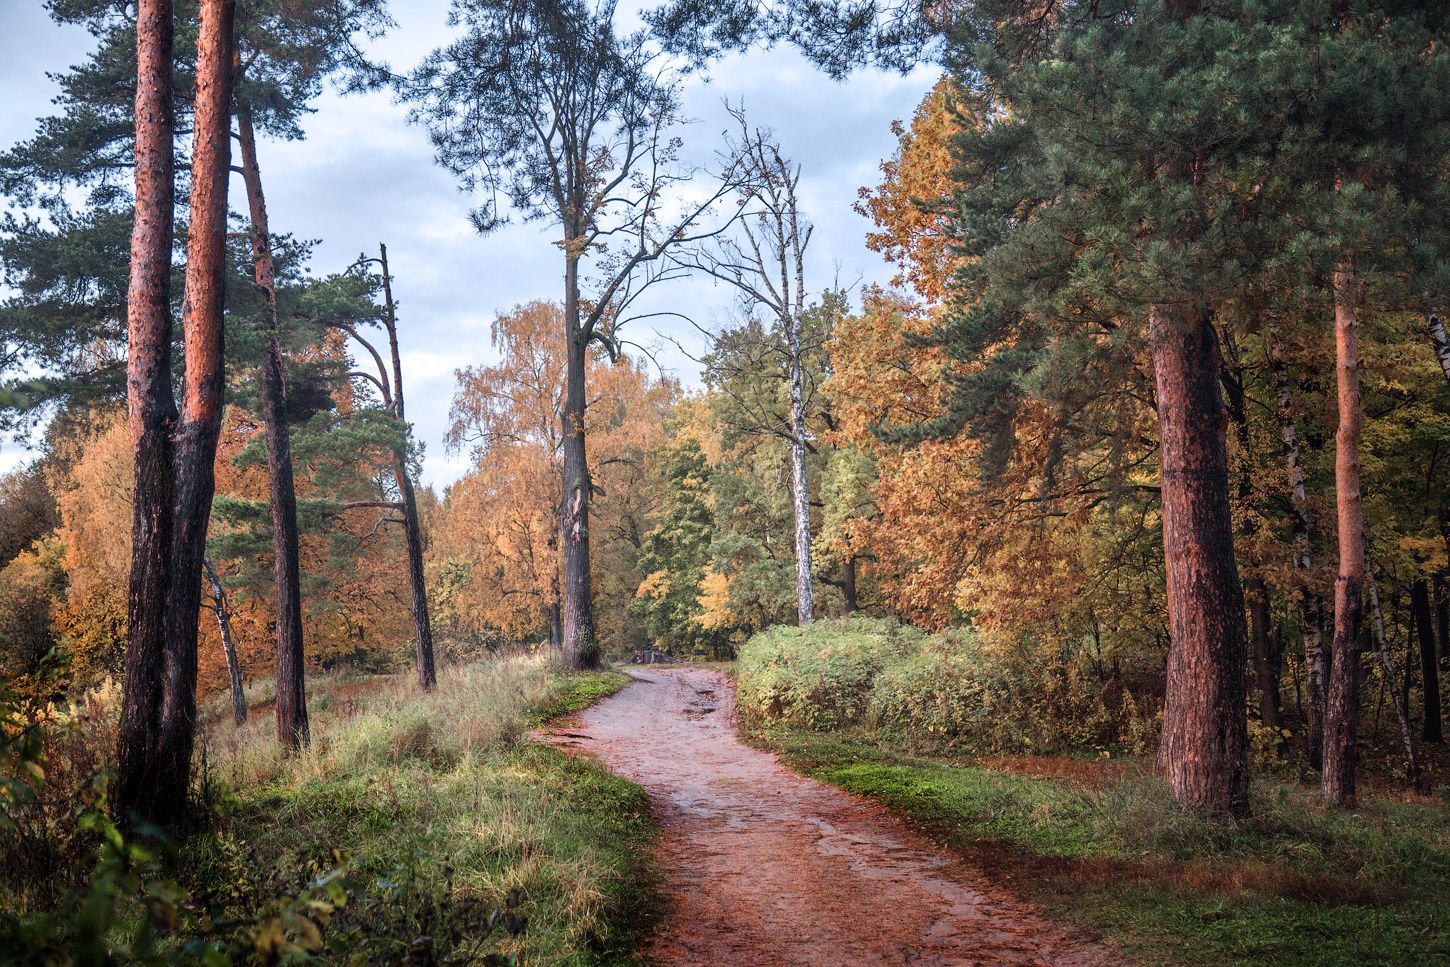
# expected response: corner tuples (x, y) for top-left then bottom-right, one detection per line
(0, 0), (935, 490)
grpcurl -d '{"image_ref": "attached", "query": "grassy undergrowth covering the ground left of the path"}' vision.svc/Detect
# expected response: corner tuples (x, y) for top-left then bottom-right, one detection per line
(0, 657), (654, 964)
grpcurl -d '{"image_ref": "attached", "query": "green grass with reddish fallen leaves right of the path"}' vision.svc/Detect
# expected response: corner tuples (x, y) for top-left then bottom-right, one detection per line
(753, 728), (1450, 964)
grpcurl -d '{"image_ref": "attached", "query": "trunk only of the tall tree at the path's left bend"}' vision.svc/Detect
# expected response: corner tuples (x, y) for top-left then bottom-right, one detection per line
(558, 247), (600, 668)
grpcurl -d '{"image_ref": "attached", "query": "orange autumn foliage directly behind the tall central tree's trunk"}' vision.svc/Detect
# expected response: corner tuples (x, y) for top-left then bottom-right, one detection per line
(429, 302), (679, 644)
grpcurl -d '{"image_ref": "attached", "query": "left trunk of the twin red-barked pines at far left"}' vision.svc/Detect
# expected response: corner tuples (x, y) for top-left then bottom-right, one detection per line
(110, 0), (187, 823)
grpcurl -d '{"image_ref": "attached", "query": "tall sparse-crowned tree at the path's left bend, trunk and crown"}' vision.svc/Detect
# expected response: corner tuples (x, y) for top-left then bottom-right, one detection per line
(400, 0), (734, 668)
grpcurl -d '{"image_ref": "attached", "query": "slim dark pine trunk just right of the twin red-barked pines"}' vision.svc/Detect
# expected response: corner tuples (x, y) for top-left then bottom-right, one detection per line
(236, 102), (309, 748)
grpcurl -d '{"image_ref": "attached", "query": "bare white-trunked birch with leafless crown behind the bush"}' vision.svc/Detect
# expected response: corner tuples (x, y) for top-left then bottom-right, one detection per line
(671, 107), (815, 625)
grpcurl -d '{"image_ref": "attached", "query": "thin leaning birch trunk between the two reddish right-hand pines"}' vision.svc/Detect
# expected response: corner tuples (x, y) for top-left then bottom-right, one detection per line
(1269, 335), (1328, 768)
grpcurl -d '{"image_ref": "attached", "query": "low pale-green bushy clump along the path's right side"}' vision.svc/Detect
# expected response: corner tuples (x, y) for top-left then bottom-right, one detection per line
(738, 618), (1151, 754)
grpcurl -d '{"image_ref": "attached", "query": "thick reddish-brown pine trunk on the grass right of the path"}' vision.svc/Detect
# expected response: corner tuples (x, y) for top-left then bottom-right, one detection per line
(1150, 307), (1248, 816)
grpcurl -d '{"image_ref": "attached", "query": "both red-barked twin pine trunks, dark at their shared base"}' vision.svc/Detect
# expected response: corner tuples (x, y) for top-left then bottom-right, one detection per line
(113, 0), (236, 822)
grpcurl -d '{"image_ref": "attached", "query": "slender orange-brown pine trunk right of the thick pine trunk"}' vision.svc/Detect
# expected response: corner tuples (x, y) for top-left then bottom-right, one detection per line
(1324, 265), (1366, 808)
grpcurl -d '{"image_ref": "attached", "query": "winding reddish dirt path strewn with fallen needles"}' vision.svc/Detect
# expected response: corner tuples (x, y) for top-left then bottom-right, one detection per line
(544, 667), (1122, 967)
